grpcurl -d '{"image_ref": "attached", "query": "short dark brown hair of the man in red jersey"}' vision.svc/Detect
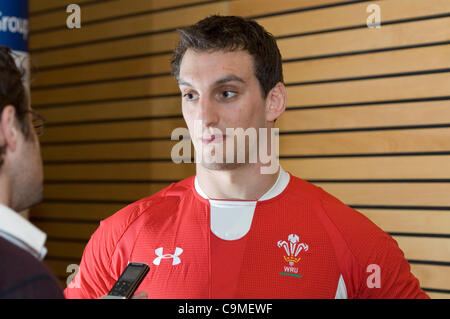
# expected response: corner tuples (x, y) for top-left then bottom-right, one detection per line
(171, 15), (284, 98)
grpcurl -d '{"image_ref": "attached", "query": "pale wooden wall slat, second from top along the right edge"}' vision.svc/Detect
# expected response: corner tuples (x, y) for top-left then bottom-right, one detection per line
(277, 18), (450, 60)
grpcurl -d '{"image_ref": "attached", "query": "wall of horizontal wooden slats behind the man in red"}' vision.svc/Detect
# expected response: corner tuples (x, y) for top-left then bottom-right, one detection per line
(30, 0), (450, 298)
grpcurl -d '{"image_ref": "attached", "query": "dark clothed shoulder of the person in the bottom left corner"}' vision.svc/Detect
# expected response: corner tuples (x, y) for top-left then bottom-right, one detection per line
(0, 237), (64, 299)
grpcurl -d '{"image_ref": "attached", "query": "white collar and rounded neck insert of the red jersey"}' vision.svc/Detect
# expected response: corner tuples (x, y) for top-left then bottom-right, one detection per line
(195, 167), (290, 240)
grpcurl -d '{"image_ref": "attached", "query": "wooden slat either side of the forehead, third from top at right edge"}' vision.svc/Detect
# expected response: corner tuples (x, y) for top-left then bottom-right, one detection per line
(34, 45), (450, 87)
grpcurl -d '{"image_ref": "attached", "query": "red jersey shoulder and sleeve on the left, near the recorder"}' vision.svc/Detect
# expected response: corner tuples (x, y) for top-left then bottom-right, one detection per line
(65, 177), (194, 298)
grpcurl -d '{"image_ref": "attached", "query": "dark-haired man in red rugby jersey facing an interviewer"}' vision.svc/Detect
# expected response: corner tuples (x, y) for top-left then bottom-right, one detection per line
(65, 16), (428, 299)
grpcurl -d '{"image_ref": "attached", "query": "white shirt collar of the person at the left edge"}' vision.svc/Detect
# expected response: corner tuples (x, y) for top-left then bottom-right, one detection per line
(0, 204), (47, 259)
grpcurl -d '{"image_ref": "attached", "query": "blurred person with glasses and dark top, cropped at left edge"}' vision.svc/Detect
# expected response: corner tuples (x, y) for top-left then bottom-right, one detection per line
(0, 47), (64, 299)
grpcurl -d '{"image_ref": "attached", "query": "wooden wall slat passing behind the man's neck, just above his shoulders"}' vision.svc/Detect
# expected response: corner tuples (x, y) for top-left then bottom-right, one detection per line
(44, 155), (450, 181)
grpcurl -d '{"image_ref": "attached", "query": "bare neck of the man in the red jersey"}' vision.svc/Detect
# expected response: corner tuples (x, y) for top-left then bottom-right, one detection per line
(197, 164), (279, 200)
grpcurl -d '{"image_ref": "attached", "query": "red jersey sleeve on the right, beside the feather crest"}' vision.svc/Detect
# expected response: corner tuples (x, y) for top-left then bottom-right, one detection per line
(321, 190), (429, 299)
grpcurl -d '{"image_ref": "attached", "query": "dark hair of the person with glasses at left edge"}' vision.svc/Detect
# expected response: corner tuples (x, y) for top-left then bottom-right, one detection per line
(0, 46), (31, 166)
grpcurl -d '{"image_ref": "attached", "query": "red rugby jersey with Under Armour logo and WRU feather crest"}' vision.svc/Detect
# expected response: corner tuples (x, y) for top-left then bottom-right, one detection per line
(65, 175), (428, 299)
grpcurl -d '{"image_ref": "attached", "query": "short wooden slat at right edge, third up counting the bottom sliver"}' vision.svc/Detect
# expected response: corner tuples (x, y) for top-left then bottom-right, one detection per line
(393, 236), (450, 264)
